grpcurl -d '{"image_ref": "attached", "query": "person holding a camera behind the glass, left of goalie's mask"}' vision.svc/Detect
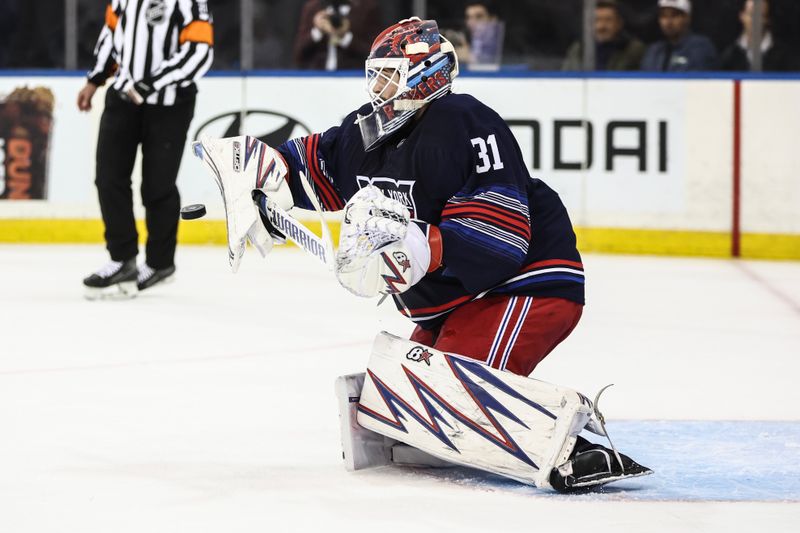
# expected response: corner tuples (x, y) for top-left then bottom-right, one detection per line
(294, 0), (382, 70)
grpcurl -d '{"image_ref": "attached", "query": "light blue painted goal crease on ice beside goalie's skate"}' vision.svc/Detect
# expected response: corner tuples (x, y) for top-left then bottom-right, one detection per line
(406, 420), (800, 502)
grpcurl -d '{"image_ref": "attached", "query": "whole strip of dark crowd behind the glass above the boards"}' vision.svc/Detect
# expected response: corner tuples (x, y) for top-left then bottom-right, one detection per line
(0, 0), (800, 72)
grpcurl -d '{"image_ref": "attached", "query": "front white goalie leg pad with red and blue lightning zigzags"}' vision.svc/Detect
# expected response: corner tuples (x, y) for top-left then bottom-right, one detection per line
(357, 333), (592, 487)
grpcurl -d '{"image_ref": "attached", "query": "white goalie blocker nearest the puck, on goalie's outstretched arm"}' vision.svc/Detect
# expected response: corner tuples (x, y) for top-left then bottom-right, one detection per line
(193, 135), (294, 272)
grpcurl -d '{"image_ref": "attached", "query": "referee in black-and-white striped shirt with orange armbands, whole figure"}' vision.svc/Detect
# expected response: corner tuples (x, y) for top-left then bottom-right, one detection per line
(78, 0), (214, 299)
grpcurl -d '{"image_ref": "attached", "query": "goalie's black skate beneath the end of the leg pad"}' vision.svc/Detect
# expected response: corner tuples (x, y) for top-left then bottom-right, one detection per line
(550, 437), (653, 492)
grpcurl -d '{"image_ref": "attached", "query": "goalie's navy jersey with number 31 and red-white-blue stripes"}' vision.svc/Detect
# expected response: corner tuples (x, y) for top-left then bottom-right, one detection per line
(278, 94), (584, 329)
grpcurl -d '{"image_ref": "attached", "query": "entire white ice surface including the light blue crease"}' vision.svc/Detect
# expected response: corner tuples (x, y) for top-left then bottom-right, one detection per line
(0, 246), (800, 533)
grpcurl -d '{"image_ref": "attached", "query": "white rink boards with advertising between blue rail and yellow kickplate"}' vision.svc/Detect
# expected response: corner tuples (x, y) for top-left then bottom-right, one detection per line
(0, 76), (800, 237)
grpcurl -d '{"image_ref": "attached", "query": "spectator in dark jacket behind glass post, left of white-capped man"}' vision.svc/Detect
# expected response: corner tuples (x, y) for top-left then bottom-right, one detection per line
(562, 0), (645, 70)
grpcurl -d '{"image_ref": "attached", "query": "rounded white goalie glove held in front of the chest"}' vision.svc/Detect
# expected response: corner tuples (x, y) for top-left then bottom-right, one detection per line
(336, 185), (431, 298)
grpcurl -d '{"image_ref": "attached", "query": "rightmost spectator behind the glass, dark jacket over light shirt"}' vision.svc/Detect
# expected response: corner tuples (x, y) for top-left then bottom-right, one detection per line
(720, 0), (800, 71)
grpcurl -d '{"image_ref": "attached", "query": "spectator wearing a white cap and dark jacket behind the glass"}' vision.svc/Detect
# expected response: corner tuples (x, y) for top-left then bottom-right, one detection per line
(642, 0), (719, 72)
